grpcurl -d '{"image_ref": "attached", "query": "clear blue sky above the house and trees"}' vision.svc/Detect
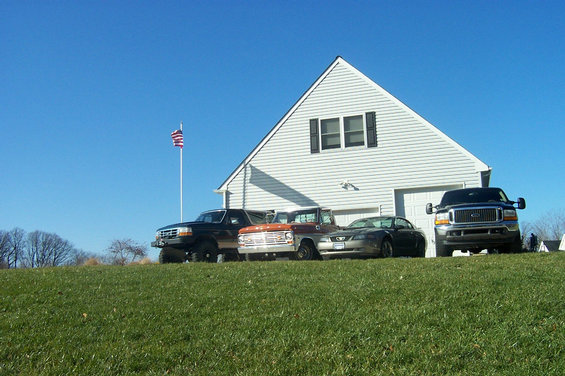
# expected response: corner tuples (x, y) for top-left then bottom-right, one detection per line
(0, 0), (565, 258)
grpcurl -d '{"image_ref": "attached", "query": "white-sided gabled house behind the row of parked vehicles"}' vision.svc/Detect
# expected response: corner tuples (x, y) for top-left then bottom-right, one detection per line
(216, 56), (491, 257)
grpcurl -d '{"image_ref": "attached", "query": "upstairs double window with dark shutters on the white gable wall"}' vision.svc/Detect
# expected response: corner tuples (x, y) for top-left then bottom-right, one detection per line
(310, 112), (377, 153)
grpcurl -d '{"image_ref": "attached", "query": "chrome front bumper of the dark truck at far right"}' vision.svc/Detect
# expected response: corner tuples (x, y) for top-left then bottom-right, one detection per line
(435, 222), (520, 250)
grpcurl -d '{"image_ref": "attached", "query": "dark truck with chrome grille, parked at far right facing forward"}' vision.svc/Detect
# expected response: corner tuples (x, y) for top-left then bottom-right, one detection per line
(426, 187), (526, 257)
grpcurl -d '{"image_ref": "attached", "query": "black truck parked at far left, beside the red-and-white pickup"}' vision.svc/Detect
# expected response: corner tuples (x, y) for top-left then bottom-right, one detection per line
(151, 209), (269, 264)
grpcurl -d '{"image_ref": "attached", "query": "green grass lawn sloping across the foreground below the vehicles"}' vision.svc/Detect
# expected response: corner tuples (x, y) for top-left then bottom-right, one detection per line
(0, 252), (565, 376)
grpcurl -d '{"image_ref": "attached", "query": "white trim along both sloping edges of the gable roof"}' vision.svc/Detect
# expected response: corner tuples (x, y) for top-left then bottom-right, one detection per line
(215, 56), (491, 193)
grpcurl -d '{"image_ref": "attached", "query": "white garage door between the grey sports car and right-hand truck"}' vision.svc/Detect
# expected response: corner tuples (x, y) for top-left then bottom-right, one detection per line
(394, 185), (461, 257)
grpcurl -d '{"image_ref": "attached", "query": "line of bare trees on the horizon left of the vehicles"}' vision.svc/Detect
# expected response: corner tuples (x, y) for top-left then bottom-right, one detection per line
(0, 228), (147, 269)
